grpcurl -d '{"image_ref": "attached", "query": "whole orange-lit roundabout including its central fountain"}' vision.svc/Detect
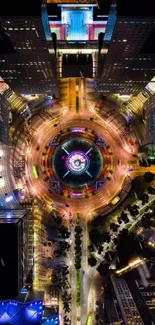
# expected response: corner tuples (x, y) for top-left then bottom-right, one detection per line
(23, 112), (132, 214)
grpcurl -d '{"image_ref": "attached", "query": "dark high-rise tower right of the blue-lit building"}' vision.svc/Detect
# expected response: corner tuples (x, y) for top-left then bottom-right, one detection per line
(98, 0), (155, 94)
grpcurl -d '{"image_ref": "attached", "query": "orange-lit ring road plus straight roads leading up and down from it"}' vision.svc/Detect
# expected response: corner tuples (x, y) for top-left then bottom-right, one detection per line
(7, 78), (146, 325)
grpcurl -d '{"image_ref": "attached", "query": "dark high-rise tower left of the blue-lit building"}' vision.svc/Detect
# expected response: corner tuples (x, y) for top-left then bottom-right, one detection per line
(0, 1), (56, 94)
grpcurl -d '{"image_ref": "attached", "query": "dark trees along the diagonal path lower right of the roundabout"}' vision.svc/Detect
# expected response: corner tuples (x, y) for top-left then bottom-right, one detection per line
(88, 172), (155, 275)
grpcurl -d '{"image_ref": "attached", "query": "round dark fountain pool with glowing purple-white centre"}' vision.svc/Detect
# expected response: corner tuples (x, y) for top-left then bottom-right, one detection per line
(51, 136), (102, 187)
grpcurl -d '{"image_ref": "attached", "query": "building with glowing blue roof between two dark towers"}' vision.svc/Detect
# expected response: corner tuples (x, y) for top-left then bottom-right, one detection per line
(47, 0), (111, 78)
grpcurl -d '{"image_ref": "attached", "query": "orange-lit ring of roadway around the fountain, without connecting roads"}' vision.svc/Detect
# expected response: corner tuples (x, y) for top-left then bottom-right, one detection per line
(27, 104), (133, 213)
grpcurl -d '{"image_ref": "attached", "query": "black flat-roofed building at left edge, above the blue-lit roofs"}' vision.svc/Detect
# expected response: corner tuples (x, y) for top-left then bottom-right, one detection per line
(0, 209), (29, 299)
